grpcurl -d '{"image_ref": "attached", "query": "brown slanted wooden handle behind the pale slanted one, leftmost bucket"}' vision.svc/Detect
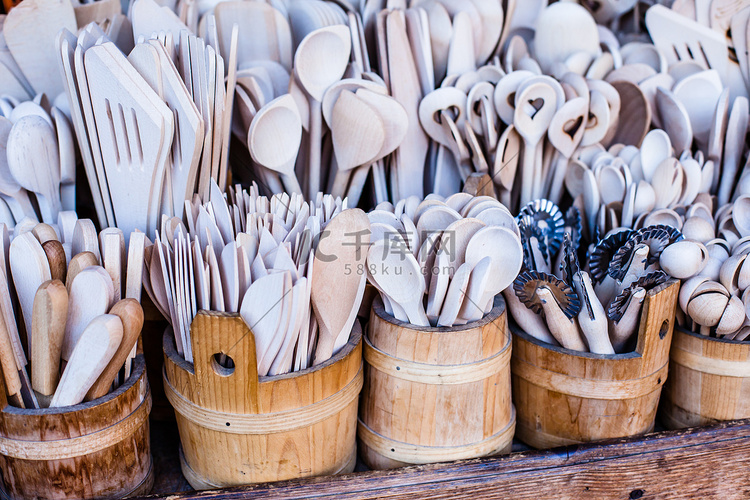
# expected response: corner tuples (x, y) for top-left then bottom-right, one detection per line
(84, 299), (143, 401)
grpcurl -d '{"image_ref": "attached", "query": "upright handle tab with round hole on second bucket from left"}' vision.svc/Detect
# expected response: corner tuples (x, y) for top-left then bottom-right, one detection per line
(190, 310), (260, 413)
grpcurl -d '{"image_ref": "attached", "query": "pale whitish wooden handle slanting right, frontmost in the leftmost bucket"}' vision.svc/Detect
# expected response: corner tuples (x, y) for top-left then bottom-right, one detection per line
(50, 314), (123, 408)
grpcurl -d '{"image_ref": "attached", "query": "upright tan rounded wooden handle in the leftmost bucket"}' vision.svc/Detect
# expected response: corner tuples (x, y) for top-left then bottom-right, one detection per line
(31, 279), (68, 396)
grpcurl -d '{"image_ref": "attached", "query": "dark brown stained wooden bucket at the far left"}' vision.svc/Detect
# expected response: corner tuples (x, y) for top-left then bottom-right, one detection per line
(0, 354), (154, 499)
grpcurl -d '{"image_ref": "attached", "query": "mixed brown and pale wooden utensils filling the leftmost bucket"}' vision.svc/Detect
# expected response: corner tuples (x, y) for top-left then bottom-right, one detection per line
(0, 212), (145, 408)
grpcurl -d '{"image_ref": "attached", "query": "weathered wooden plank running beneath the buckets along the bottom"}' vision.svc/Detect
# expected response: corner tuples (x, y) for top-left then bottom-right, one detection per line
(141, 419), (750, 500)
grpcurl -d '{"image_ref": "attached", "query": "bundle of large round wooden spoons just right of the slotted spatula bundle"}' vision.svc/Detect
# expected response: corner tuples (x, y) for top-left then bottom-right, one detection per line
(214, 0), (408, 205)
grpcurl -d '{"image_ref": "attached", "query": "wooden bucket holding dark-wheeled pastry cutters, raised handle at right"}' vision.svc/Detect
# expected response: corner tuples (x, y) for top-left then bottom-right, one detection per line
(511, 280), (680, 448)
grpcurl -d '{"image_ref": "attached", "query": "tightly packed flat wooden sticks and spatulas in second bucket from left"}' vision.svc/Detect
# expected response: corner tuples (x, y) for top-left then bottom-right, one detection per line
(144, 182), (370, 375)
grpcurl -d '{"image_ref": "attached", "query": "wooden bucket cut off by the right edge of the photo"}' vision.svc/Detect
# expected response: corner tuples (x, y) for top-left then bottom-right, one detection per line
(659, 326), (750, 429)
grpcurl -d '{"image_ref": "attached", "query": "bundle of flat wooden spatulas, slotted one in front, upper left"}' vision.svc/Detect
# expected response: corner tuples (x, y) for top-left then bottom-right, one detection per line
(56, 0), (236, 234)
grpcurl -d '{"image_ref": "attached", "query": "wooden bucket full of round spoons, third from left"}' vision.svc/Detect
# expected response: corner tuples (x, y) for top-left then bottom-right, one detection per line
(358, 296), (515, 469)
